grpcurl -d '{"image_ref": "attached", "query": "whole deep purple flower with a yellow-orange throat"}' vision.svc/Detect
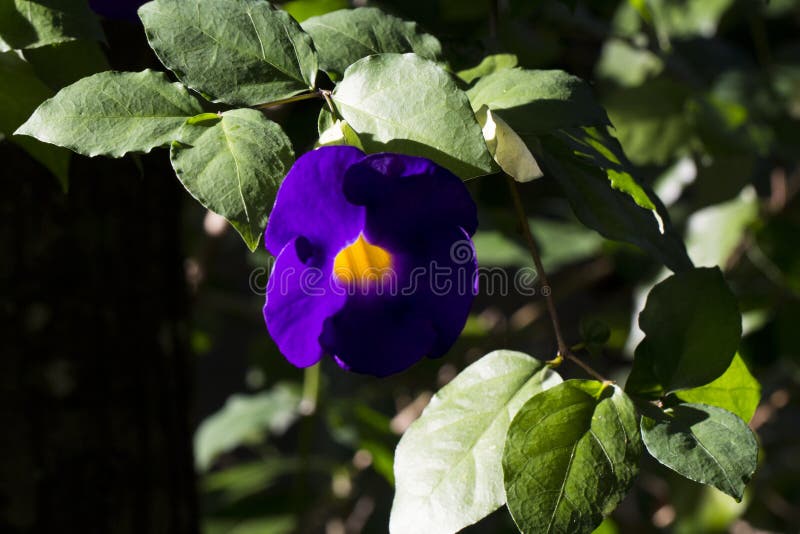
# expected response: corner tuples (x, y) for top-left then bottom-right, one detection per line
(264, 146), (478, 376)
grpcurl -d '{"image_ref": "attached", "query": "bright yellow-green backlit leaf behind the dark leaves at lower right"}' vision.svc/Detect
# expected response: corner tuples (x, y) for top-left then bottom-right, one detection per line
(676, 354), (761, 422)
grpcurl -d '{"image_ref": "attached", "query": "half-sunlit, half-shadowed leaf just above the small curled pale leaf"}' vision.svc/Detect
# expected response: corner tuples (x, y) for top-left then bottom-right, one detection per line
(467, 69), (610, 137)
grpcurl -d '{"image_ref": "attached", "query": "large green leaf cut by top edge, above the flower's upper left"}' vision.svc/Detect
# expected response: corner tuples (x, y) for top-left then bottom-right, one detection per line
(139, 0), (317, 105)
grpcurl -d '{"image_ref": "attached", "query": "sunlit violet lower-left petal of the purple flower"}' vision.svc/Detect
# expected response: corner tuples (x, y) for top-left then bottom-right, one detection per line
(264, 237), (346, 367)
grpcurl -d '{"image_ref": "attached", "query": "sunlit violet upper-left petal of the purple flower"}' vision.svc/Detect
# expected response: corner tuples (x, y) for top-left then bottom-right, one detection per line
(264, 146), (364, 256)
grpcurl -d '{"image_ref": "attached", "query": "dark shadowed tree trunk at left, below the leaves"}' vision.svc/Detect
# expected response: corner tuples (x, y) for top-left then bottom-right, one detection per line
(0, 142), (197, 534)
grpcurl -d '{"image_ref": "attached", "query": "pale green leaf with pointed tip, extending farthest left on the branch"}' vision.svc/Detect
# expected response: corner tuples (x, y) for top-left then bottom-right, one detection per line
(16, 70), (203, 158)
